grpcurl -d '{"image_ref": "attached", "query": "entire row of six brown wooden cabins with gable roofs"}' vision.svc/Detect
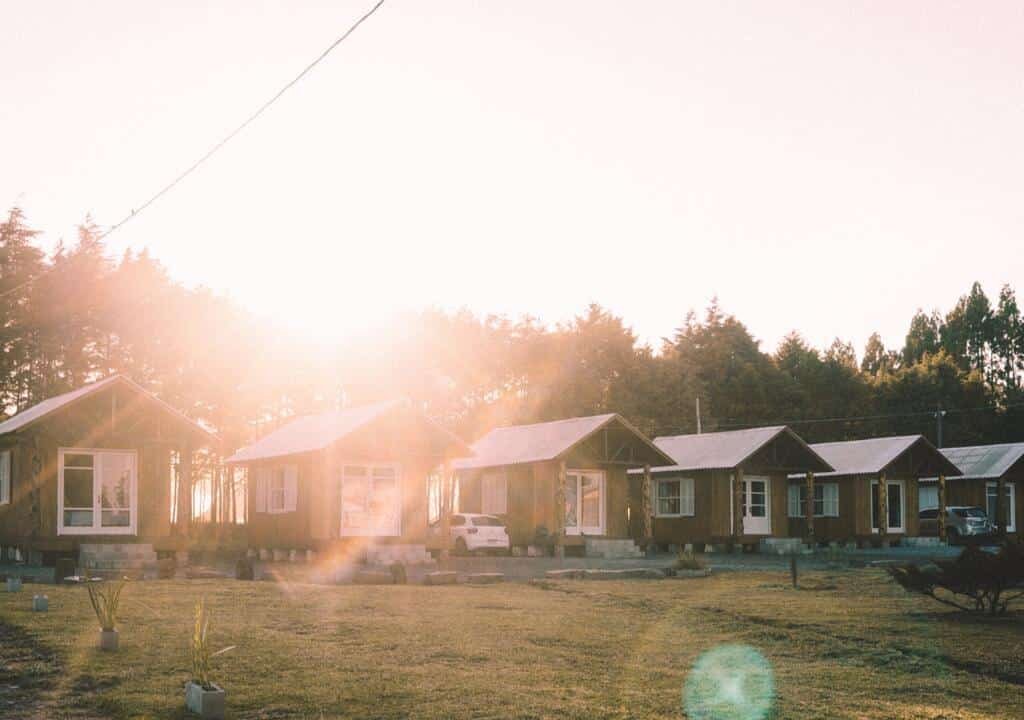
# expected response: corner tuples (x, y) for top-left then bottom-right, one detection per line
(0, 376), (1024, 564)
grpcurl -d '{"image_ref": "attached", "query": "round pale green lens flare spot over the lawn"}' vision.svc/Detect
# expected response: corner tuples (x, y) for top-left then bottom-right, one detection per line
(683, 645), (775, 720)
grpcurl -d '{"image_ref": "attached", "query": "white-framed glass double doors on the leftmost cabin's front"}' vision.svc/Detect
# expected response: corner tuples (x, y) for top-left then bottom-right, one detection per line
(57, 449), (138, 535)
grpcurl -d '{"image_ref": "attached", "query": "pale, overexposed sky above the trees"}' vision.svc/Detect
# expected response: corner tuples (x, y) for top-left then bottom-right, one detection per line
(0, 0), (1024, 358)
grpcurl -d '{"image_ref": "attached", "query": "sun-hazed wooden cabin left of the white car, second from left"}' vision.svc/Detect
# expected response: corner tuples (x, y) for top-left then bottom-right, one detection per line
(227, 401), (470, 563)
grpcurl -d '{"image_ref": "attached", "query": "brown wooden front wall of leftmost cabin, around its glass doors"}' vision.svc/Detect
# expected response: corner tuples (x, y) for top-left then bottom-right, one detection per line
(0, 385), (195, 551)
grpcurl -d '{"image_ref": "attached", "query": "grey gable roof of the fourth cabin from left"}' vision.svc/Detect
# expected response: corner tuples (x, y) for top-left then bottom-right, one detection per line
(651, 425), (831, 472)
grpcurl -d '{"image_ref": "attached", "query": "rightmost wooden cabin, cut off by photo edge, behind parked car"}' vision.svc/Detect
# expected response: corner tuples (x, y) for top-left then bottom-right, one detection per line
(919, 442), (1024, 538)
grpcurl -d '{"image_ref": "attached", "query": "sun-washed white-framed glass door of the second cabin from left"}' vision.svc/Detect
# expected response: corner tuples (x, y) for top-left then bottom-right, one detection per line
(341, 464), (401, 537)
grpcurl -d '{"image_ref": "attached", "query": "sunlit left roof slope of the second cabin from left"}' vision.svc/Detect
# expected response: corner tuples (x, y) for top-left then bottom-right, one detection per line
(225, 400), (400, 463)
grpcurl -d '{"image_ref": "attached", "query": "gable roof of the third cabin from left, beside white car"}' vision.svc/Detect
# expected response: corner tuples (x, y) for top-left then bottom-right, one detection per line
(453, 413), (671, 470)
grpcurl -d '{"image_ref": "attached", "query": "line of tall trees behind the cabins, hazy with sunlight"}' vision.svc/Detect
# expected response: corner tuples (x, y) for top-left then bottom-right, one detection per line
(0, 207), (1024, 448)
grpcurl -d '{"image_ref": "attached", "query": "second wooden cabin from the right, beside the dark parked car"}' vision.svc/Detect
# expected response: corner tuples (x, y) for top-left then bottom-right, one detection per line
(787, 435), (961, 544)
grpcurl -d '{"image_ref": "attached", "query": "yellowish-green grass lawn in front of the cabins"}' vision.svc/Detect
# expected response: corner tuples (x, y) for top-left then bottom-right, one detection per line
(0, 569), (1024, 720)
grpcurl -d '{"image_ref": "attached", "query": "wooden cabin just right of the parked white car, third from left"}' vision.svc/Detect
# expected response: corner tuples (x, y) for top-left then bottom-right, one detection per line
(455, 414), (671, 557)
